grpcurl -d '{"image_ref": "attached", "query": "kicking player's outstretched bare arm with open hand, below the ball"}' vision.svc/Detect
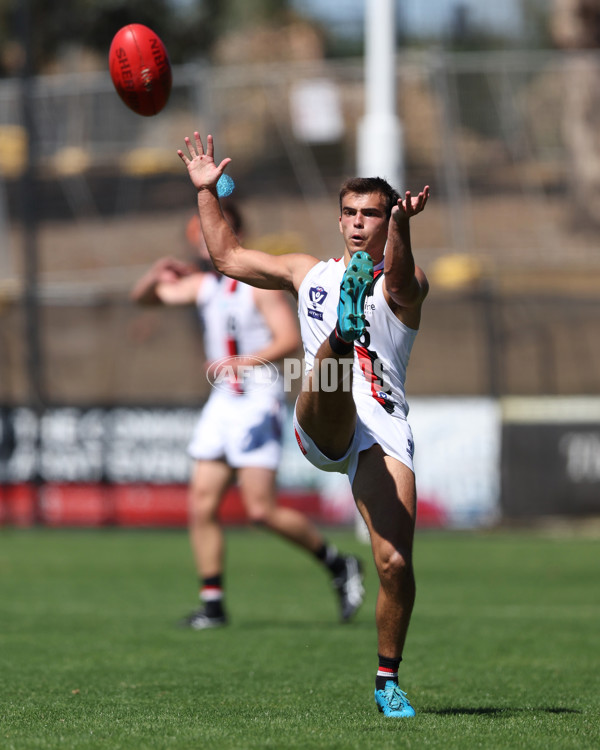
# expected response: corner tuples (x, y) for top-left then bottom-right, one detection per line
(177, 133), (317, 292)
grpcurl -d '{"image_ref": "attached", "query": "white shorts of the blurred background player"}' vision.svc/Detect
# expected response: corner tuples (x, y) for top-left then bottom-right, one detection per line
(188, 390), (283, 469)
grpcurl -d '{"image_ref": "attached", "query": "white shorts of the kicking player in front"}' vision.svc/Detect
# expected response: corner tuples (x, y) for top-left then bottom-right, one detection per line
(294, 394), (414, 484)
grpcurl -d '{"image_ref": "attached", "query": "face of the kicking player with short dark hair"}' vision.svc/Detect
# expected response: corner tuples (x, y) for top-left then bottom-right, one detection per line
(340, 193), (388, 263)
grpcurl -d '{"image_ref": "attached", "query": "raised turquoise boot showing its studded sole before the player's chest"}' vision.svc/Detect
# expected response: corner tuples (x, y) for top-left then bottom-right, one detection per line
(337, 251), (373, 342)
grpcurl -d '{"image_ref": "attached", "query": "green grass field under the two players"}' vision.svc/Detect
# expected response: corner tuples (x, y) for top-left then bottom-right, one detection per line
(0, 529), (600, 750)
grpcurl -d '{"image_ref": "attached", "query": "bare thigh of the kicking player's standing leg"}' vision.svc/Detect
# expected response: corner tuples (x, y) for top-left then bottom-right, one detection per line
(352, 445), (417, 562)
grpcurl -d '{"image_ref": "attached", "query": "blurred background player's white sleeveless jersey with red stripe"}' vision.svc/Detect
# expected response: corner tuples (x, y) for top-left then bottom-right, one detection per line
(196, 274), (282, 393)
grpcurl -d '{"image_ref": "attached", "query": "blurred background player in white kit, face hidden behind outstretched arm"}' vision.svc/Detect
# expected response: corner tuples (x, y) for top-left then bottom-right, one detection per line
(131, 202), (364, 630)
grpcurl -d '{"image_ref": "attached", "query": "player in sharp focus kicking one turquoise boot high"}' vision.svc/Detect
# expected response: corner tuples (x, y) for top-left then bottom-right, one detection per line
(178, 133), (429, 717)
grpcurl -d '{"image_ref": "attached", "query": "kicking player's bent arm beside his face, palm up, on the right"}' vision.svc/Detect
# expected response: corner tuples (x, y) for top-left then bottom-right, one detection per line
(384, 185), (429, 318)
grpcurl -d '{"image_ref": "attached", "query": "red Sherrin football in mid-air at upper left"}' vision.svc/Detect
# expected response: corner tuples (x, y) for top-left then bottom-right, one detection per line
(108, 23), (173, 117)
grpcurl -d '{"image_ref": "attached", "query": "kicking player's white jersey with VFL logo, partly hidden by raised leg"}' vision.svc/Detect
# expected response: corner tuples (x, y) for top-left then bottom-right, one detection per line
(298, 259), (417, 419)
